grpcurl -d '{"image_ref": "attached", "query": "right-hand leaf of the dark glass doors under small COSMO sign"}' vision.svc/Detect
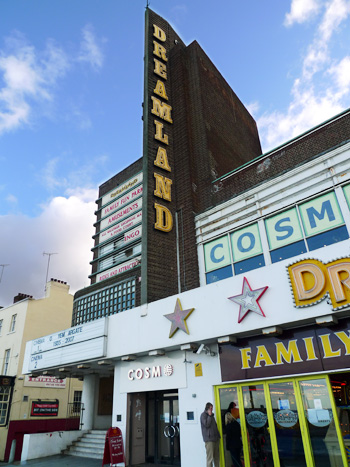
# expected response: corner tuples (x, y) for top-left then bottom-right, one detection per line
(156, 393), (180, 465)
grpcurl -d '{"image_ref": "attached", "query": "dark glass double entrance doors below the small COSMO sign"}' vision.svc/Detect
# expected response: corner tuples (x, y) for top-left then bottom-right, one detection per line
(146, 391), (180, 466)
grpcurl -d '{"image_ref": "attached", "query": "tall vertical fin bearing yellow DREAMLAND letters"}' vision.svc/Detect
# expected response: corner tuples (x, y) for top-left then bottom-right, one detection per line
(141, 8), (184, 303)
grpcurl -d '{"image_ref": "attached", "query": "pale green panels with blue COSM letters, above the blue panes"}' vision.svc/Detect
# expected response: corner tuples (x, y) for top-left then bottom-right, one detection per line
(204, 187), (350, 273)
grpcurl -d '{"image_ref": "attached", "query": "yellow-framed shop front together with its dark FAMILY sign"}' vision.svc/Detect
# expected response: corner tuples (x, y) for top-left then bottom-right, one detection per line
(215, 320), (350, 467)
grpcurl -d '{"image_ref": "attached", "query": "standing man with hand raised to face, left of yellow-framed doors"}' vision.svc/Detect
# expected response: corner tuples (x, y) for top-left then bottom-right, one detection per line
(201, 402), (220, 467)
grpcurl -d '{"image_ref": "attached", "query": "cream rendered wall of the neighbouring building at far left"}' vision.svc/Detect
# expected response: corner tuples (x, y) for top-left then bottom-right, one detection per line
(0, 281), (82, 459)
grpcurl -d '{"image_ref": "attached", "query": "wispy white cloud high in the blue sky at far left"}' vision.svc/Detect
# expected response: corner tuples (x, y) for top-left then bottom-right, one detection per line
(0, 35), (68, 135)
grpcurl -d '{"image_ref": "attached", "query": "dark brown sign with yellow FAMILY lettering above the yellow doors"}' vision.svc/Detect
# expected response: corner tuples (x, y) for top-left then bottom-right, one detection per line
(219, 320), (350, 381)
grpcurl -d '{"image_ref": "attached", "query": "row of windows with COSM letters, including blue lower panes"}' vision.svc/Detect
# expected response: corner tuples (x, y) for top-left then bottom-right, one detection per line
(203, 188), (350, 284)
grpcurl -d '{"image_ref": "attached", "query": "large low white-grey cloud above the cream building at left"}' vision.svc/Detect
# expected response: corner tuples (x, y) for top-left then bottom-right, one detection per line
(0, 189), (97, 306)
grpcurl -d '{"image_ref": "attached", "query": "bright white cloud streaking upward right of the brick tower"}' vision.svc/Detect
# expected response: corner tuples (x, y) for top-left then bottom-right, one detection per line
(257, 0), (350, 151)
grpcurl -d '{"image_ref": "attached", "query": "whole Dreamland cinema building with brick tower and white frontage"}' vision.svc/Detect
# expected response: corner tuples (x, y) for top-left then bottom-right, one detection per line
(23, 9), (350, 467)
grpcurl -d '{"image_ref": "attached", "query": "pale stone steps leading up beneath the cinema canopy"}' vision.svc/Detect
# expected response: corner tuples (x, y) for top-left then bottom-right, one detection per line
(63, 430), (106, 460)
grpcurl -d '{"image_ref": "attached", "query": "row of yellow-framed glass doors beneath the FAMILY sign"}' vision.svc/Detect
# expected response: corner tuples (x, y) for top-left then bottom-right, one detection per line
(216, 376), (350, 467)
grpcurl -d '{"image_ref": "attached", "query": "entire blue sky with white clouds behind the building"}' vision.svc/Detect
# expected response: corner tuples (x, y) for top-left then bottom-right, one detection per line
(0, 0), (350, 305)
